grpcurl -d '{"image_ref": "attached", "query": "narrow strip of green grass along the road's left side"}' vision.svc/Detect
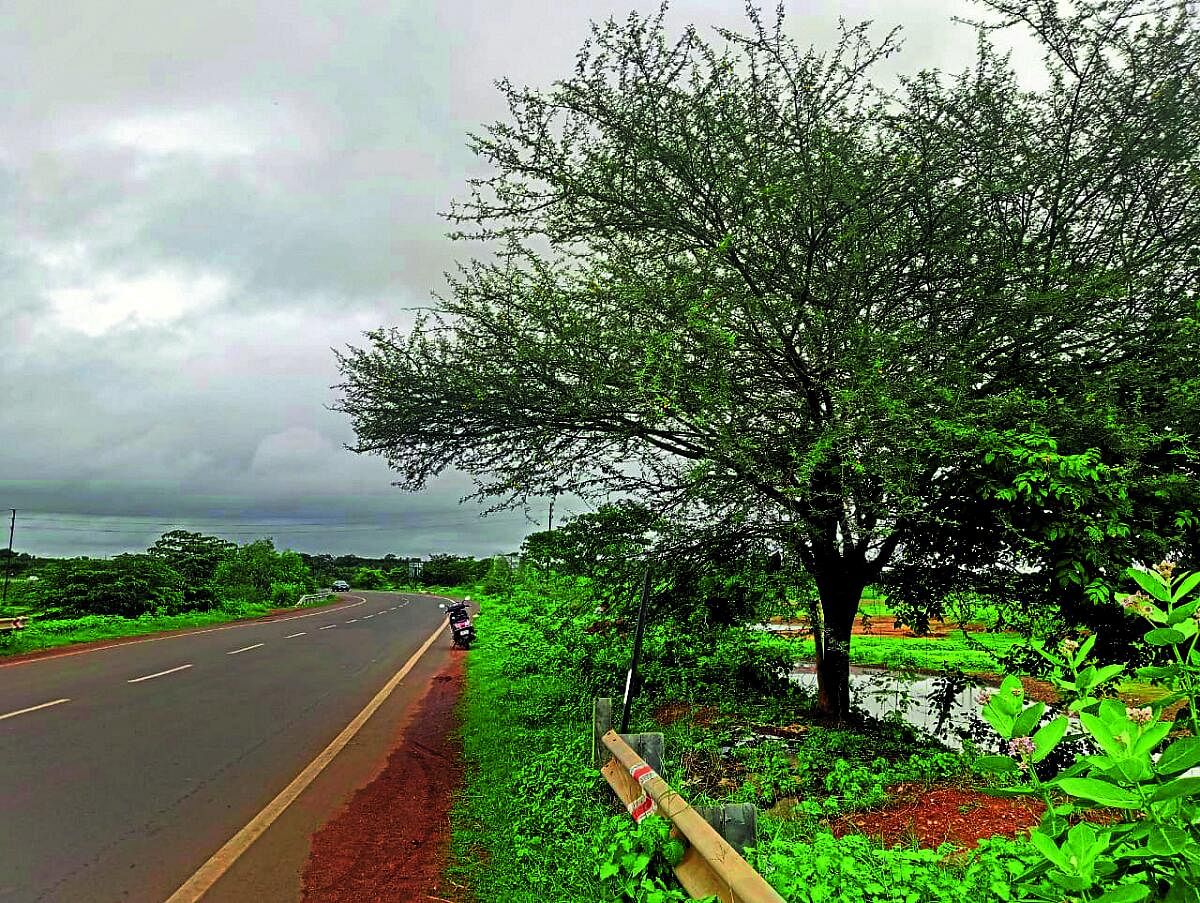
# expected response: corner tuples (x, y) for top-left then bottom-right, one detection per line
(0, 597), (332, 656)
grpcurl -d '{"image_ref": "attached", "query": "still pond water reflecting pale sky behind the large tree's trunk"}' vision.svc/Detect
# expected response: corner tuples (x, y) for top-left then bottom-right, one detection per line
(791, 662), (997, 749)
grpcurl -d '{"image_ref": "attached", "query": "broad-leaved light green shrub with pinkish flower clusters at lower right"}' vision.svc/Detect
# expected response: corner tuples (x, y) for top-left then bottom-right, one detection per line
(984, 566), (1200, 903)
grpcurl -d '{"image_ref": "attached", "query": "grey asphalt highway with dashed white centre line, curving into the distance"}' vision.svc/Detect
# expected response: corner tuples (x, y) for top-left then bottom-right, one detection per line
(0, 593), (448, 903)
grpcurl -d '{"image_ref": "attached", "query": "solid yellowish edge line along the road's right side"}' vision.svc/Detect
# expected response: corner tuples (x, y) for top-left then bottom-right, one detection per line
(167, 623), (446, 903)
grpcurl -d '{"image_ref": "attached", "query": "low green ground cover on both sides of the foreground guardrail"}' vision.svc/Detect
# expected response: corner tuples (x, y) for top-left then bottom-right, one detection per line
(451, 573), (1051, 903)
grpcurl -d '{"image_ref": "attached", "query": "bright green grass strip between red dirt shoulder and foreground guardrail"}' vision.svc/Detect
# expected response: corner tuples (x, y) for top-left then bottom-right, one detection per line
(450, 599), (612, 903)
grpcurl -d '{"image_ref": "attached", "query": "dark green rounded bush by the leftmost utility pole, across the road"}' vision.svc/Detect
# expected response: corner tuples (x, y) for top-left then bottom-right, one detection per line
(28, 555), (184, 617)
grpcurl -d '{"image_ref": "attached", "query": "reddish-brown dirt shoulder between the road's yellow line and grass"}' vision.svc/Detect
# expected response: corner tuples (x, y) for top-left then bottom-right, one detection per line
(302, 653), (464, 903)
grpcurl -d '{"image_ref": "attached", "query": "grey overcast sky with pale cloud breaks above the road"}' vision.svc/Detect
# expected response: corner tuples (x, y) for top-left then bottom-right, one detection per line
(0, 0), (1036, 555)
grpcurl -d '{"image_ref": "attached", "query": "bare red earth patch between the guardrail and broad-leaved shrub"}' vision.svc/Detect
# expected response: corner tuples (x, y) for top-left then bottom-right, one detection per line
(832, 784), (1045, 849)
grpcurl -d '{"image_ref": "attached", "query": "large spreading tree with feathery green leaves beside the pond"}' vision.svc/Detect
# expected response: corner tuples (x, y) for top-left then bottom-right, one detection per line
(340, 0), (1200, 714)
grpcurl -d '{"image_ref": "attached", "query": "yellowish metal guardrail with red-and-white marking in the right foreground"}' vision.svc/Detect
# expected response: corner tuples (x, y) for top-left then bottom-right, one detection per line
(599, 730), (785, 903)
